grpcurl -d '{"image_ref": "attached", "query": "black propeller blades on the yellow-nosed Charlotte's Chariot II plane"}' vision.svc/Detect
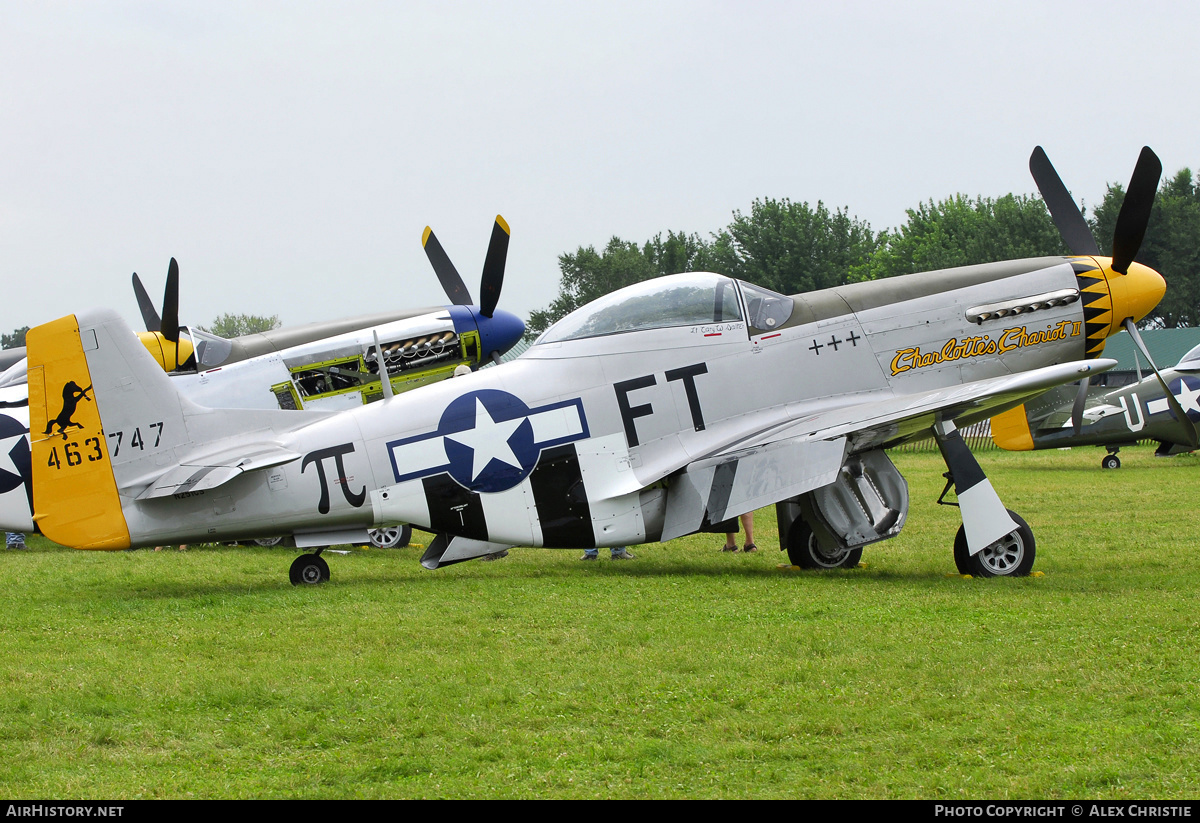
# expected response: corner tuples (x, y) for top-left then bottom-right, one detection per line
(1030, 146), (1166, 443)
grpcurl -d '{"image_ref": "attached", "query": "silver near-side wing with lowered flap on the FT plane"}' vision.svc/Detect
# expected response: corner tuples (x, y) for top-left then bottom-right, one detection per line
(662, 359), (1117, 540)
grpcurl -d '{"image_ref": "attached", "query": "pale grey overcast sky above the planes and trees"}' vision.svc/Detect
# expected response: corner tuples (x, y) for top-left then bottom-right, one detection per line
(0, 0), (1200, 331)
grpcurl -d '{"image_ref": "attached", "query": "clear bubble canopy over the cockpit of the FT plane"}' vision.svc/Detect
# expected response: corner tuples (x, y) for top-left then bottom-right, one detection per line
(538, 272), (758, 343)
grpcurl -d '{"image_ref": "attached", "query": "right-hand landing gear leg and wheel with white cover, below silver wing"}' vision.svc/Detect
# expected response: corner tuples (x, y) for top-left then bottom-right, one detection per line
(934, 421), (1034, 577)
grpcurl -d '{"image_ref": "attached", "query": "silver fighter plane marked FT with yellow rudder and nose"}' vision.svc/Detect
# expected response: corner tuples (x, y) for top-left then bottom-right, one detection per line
(28, 150), (1165, 582)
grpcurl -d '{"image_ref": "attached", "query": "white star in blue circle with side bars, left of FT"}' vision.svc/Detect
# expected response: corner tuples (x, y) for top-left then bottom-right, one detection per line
(388, 389), (588, 493)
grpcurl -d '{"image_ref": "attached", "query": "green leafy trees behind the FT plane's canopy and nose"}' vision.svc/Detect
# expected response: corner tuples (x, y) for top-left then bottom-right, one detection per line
(528, 168), (1200, 337)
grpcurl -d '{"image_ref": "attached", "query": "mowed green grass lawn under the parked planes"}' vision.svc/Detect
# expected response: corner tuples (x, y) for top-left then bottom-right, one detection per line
(0, 449), (1200, 798)
